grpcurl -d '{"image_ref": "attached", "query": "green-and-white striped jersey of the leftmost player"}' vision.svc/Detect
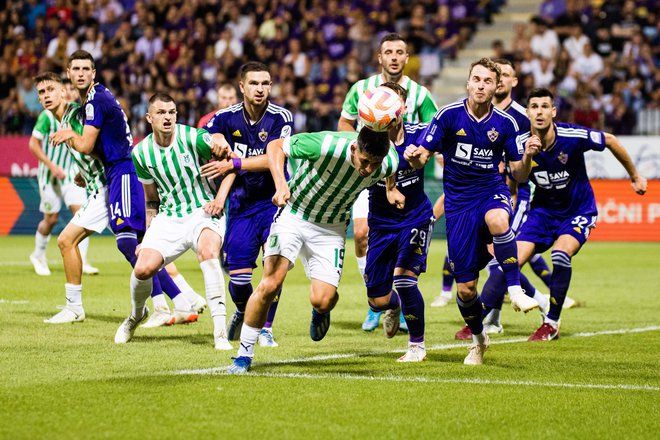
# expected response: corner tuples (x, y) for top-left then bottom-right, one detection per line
(32, 110), (78, 187)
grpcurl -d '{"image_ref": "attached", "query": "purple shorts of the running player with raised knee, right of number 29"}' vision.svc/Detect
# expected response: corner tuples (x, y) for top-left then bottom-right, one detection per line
(446, 193), (512, 283)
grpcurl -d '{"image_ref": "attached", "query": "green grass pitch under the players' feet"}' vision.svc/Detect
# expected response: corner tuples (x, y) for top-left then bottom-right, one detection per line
(0, 236), (660, 439)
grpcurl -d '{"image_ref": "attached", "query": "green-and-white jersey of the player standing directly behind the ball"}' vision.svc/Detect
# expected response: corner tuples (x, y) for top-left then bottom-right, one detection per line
(341, 74), (438, 127)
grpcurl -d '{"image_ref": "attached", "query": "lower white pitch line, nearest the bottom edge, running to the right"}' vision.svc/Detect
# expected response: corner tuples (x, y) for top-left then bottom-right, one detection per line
(227, 373), (660, 391)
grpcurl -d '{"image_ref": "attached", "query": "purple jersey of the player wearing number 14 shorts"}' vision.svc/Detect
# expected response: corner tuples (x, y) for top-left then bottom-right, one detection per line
(84, 83), (135, 174)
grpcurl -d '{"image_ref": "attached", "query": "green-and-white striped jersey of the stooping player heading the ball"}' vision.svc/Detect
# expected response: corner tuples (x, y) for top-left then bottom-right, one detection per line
(283, 131), (399, 224)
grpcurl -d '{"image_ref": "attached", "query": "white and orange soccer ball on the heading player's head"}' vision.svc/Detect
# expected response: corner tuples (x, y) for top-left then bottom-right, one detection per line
(358, 86), (403, 131)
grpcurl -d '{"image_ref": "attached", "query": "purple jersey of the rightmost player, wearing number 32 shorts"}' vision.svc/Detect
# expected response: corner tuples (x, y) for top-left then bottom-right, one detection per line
(520, 122), (605, 218)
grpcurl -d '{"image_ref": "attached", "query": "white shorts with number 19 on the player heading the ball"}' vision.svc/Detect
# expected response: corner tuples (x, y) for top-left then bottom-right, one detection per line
(264, 207), (347, 287)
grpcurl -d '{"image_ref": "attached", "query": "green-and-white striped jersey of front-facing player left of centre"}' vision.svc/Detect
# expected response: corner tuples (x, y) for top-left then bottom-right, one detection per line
(132, 124), (214, 217)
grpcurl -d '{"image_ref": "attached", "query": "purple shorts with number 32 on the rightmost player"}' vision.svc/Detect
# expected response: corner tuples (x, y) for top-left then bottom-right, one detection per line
(516, 208), (598, 253)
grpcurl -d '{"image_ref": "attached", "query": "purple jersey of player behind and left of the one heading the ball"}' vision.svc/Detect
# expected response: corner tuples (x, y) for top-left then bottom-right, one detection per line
(206, 102), (293, 216)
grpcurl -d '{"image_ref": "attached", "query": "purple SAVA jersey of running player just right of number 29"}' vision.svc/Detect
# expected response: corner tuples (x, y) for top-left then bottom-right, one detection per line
(420, 99), (524, 215)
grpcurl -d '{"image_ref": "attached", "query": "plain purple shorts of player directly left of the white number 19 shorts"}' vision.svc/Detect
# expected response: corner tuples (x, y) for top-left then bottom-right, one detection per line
(223, 205), (277, 270)
